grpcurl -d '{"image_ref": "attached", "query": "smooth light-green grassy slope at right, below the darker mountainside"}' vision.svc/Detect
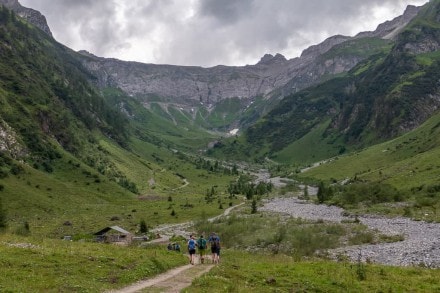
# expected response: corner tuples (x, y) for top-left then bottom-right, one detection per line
(300, 109), (440, 190)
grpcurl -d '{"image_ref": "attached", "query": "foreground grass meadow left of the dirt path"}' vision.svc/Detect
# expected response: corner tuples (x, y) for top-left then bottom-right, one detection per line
(0, 234), (187, 292)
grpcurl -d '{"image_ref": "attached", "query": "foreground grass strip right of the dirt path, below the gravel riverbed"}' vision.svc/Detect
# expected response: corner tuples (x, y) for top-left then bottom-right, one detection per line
(182, 249), (440, 293)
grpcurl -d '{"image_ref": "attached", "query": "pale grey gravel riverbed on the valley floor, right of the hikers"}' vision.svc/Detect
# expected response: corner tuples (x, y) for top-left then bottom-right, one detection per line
(259, 198), (440, 268)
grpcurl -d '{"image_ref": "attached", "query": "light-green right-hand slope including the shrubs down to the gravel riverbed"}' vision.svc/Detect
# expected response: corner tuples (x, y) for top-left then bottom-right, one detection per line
(296, 110), (440, 221)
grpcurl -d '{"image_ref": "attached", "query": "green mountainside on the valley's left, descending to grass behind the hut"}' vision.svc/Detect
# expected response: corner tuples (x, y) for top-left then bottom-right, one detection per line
(0, 7), (237, 238)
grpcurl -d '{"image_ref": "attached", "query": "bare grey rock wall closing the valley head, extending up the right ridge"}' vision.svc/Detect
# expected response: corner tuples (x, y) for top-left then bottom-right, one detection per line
(82, 6), (419, 115)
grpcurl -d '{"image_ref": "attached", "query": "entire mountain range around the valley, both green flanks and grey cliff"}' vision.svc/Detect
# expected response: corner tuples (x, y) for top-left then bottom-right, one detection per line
(0, 0), (440, 230)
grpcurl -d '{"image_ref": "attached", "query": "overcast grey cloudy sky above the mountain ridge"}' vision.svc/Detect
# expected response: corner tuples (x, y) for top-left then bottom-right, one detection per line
(19, 0), (428, 67)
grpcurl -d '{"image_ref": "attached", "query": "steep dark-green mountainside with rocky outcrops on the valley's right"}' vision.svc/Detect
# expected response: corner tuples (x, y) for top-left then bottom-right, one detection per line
(210, 1), (440, 164)
